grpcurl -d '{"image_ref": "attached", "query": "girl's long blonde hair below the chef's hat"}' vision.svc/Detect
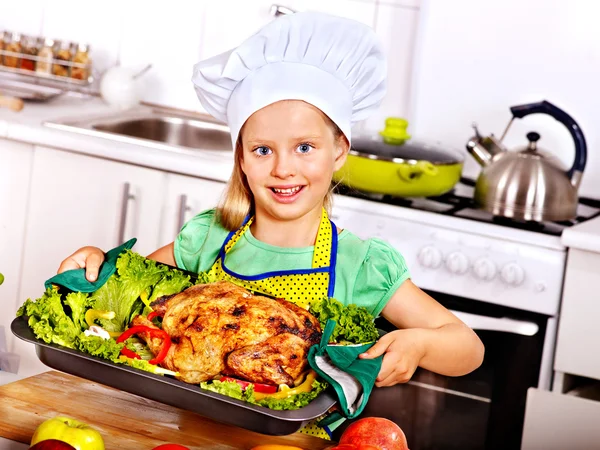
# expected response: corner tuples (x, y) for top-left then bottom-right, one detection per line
(217, 114), (348, 231)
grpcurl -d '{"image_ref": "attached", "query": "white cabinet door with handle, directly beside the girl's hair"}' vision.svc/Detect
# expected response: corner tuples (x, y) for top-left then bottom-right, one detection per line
(160, 174), (226, 246)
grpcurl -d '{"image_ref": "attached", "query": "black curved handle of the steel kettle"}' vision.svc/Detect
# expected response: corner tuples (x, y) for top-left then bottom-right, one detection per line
(510, 100), (587, 180)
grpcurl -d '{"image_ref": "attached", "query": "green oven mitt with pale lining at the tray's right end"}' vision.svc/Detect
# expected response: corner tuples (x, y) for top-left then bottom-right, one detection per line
(308, 320), (383, 425)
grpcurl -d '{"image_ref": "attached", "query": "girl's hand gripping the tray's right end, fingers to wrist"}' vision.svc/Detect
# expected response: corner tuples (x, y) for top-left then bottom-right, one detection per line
(359, 329), (425, 387)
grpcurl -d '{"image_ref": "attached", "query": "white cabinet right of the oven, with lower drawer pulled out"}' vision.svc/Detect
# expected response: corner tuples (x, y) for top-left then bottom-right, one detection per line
(522, 248), (600, 450)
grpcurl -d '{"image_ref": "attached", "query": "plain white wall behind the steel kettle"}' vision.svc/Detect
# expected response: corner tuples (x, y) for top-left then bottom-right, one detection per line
(410, 0), (600, 198)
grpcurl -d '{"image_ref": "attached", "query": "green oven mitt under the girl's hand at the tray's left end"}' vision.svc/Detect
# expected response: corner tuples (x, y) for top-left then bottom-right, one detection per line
(44, 238), (137, 292)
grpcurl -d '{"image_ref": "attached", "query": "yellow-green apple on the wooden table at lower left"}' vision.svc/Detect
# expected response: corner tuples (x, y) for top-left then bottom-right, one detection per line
(30, 416), (104, 450)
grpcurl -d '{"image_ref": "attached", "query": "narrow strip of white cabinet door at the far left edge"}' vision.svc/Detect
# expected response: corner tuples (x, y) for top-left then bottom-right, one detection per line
(0, 139), (33, 364)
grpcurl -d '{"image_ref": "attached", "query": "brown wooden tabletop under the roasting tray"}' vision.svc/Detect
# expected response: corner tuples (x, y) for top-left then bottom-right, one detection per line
(0, 371), (332, 450)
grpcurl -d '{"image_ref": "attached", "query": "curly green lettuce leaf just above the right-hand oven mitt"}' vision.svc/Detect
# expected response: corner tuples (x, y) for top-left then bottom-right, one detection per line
(309, 298), (379, 344)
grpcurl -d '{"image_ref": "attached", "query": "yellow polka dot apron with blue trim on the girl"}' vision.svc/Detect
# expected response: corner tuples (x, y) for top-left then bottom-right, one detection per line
(208, 209), (338, 439)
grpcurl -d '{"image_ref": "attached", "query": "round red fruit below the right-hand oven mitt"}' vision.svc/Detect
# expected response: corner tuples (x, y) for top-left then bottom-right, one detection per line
(340, 417), (408, 450)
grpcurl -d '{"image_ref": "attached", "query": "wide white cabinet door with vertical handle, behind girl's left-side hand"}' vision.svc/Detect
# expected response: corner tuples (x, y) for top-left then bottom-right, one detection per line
(15, 147), (166, 376)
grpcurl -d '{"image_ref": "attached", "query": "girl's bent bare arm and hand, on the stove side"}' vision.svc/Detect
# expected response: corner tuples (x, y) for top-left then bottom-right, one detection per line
(361, 280), (484, 386)
